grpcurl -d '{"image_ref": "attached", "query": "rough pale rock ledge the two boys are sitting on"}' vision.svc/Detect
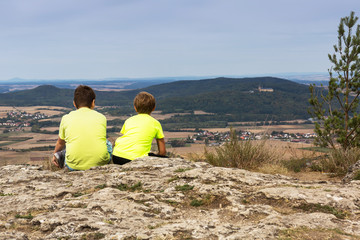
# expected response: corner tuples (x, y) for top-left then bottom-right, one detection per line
(0, 157), (360, 240)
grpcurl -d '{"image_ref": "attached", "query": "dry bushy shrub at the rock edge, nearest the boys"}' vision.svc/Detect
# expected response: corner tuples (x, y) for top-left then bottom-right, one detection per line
(204, 130), (275, 170)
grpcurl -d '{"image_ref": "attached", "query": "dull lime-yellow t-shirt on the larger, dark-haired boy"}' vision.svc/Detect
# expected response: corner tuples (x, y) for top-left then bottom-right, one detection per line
(59, 107), (110, 170)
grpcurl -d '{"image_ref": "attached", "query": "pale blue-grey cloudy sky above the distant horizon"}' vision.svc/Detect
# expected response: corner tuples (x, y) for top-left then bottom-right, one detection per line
(0, 0), (360, 80)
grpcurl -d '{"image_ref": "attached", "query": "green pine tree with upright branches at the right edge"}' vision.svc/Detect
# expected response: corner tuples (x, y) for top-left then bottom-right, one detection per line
(309, 12), (360, 150)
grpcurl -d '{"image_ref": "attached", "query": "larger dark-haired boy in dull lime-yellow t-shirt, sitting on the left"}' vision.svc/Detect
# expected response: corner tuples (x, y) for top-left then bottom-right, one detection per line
(53, 85), (111, 170)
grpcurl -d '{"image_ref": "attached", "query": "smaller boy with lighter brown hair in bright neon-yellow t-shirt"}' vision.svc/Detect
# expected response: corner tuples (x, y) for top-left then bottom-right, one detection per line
(113, 92), (166, 165)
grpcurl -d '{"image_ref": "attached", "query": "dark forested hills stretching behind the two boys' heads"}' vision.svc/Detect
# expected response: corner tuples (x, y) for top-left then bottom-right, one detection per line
(0, 77), (310, 121)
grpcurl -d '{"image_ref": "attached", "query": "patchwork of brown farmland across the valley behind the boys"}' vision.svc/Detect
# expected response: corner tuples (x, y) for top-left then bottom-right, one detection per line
(0, 106), (313, 169)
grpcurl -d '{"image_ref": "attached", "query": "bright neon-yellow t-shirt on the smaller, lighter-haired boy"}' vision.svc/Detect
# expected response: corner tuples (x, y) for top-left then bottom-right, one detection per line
(113, 114), (164, 160)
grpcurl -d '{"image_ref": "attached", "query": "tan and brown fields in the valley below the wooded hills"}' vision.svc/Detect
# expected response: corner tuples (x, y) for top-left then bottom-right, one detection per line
(0, 106), (332, 180)
